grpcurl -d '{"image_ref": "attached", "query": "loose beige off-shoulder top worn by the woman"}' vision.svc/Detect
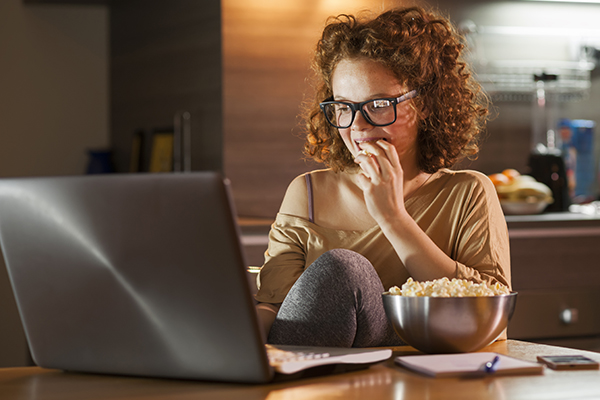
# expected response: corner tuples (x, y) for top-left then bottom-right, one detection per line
(256, 169), (510, 303)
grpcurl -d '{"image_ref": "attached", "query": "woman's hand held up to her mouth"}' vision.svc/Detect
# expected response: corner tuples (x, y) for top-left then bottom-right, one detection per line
(355, 140), (405, 225)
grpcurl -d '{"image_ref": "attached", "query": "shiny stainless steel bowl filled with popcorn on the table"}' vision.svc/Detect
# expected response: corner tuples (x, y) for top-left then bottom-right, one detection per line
(382, 292), (517, 353)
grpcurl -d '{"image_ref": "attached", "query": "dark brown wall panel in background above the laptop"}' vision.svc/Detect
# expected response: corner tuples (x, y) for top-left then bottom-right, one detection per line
(110, 0), (223, 172)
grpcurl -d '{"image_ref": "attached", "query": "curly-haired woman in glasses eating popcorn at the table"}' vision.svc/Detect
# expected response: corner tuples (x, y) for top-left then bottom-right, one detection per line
(256, 7), (510, 347)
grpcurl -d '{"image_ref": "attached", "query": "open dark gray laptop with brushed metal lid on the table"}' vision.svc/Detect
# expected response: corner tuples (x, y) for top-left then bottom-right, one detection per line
(0, 172), (391, 383)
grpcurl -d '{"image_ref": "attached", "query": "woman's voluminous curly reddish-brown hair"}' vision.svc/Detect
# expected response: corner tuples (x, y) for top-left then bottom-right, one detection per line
(304, 7), (489, 173)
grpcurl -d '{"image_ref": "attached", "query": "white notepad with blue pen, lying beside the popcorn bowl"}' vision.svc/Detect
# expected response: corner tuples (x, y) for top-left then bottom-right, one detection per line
(395, 353), (544, 378)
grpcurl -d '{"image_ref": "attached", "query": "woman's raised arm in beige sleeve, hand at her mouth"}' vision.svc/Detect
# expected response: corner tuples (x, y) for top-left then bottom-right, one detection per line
(357, 142), (510, 286)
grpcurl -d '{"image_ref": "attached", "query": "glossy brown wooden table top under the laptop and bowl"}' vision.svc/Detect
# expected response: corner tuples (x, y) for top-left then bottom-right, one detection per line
(0, 340), (600, 400)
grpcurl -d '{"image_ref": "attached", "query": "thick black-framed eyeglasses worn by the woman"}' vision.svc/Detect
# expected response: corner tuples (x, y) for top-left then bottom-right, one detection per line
(320, 90), (418, 129)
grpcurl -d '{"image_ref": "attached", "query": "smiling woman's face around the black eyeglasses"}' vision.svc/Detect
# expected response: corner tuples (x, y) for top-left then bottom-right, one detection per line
(331, 58), (418, 167)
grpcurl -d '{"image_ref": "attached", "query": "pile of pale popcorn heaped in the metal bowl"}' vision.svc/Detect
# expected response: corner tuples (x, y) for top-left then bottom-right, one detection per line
(389, 277), (510, 297)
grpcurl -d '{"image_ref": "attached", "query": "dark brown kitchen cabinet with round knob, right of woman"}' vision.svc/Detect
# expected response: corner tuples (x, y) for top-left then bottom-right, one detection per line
(506, 212), (600, 350)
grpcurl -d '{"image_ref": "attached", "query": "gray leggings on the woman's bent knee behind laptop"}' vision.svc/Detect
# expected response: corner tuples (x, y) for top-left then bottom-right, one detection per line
(268, 249), (404, 347)
